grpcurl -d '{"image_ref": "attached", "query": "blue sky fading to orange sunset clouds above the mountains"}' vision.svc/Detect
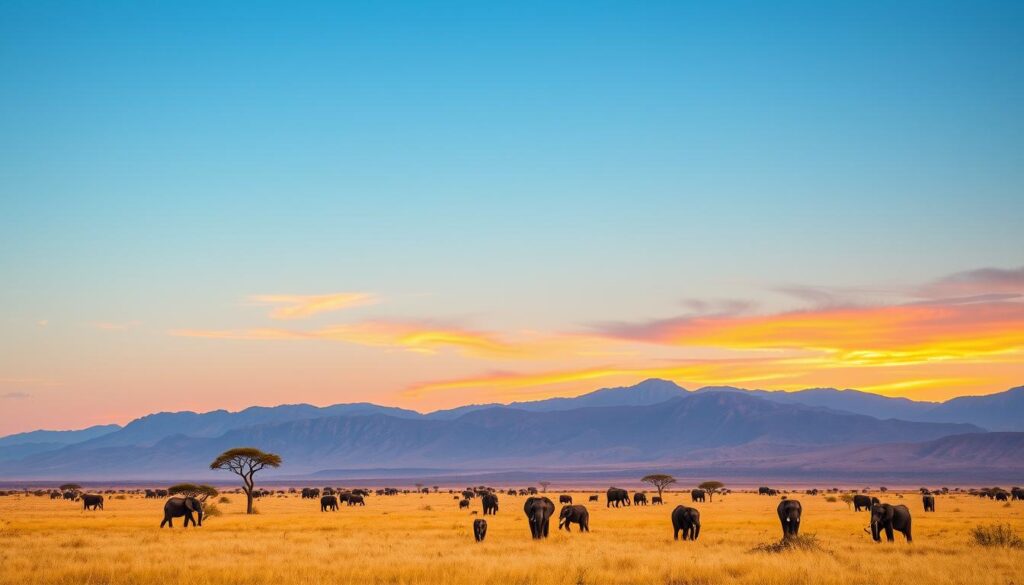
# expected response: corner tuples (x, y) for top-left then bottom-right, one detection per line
(0, 0), (1024, 433)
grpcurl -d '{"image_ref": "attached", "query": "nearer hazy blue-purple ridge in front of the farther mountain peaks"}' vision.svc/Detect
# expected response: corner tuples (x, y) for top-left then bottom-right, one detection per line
(0, 392), (980, 477)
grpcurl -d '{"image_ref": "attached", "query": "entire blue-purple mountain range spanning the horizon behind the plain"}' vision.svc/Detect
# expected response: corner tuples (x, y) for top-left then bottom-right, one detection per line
(0, 379), (1024, 479)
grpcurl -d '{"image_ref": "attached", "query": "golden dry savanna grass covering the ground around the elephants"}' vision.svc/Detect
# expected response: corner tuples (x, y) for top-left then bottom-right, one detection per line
(0, 491), (1024, 585)
